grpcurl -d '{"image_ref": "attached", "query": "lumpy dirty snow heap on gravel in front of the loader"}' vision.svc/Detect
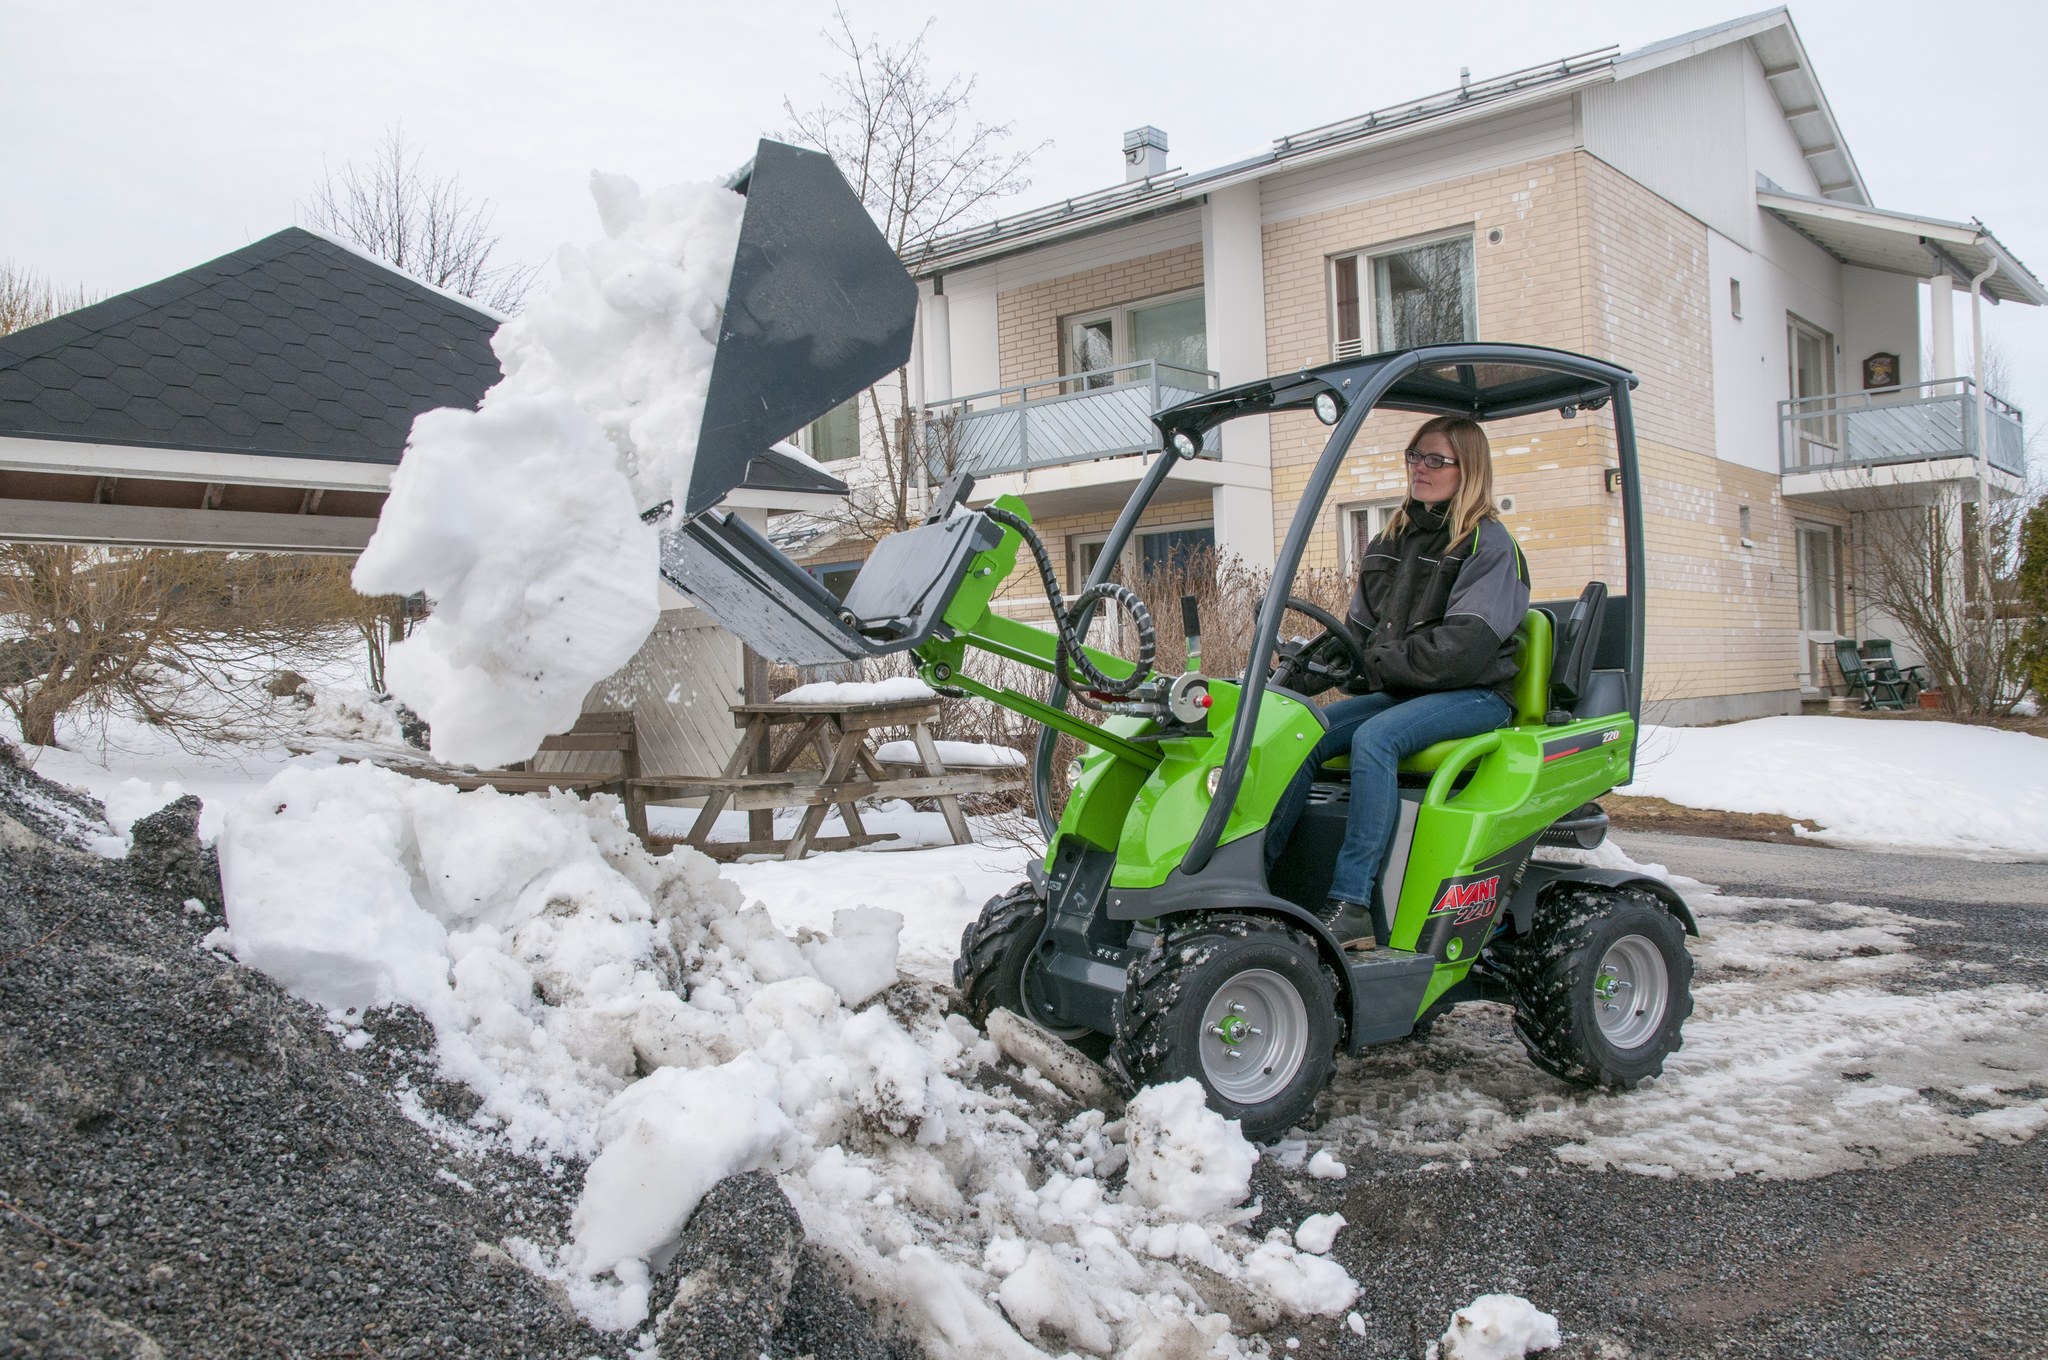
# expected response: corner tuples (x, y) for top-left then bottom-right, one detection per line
(213, 762), (1358, 1360)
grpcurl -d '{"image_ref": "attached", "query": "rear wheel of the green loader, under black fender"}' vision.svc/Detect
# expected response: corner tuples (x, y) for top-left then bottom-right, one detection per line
(1499, 889), (1692, 1090)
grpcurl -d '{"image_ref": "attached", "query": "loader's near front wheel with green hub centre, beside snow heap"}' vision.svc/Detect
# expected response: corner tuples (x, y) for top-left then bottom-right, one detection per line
(1110, 913), (1337, 1139)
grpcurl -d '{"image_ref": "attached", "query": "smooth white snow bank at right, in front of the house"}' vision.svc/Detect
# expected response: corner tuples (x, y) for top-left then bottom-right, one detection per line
(1620, 717), (2048, 856)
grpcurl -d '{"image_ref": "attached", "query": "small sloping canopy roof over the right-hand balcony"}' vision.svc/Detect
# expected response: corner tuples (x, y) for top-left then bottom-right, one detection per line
(1757, 184), (2048, 307)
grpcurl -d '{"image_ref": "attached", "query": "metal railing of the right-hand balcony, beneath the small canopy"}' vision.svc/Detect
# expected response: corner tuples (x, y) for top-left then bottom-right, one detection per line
(1778, 377), (2028, 477)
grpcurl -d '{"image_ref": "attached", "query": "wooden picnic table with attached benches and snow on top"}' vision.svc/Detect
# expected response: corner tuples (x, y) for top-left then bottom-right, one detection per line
(631, 698), (1024, 860)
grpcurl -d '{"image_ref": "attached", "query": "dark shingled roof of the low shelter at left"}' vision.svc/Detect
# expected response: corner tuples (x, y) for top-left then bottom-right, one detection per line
(0, 227), (498, 463)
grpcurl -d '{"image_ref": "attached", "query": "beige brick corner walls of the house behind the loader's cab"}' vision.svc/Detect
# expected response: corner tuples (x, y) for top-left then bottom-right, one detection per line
(1266, 152), (1798, 700)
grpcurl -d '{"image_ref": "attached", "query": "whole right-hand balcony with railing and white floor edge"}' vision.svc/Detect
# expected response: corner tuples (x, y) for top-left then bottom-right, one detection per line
(1778, 379), (2028, 510)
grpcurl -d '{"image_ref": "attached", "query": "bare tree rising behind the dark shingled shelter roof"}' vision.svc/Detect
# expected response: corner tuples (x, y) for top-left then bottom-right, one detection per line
(299, 125), (541, 313)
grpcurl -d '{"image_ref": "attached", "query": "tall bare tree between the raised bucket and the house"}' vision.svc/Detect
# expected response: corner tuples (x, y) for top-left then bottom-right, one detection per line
(782, 6), (1049, 541)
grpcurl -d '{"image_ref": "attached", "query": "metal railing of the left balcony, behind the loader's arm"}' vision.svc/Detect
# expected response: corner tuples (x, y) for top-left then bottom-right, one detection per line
(924, 358), (1221, 479)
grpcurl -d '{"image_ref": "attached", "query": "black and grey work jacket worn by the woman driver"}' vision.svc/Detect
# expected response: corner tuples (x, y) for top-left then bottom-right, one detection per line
(1350, 500), (1530, 694)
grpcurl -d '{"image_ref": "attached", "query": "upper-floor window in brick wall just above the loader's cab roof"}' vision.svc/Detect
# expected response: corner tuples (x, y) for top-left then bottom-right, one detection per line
(1329, 236), (1479, 358)
